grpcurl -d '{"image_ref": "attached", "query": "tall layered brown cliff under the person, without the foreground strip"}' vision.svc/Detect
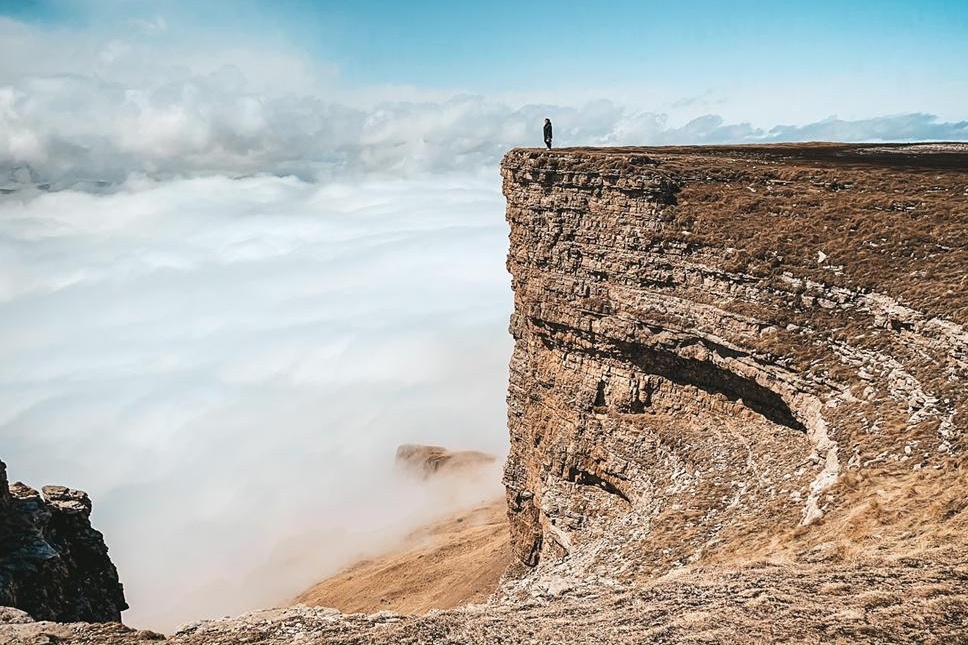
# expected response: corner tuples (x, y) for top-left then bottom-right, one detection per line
(502, 145), (968, 584)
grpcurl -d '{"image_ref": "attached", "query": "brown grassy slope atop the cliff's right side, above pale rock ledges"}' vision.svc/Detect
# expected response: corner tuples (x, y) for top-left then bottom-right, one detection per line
(656, 144), (968, 324)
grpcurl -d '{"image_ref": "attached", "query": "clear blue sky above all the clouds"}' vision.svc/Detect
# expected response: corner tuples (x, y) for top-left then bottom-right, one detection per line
(0, 0), (968, 93)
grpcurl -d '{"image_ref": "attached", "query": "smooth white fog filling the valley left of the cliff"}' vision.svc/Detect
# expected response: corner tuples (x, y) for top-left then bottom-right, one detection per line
(0, 172), (511, 630)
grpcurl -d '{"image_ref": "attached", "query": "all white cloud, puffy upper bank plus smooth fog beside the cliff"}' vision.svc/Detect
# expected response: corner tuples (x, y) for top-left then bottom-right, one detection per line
(0, 13), (968, 629)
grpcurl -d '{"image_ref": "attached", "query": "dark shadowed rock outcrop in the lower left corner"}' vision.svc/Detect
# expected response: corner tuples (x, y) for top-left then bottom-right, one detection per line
(0, 462), (128, 622)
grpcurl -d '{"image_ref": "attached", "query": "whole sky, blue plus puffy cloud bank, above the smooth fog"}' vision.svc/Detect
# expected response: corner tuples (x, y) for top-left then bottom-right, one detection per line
(0, 0), (968, 183)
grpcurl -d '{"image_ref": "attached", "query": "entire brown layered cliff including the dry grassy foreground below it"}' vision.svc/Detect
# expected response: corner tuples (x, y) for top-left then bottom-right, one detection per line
(0, 144), (968, 645)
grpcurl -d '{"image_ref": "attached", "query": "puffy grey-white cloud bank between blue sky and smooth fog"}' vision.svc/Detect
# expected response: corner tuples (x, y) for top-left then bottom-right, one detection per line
(0, 20), (968, 188)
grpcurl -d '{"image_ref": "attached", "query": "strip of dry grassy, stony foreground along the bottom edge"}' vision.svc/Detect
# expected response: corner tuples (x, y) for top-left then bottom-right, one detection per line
(0, 559), (968, 645)
